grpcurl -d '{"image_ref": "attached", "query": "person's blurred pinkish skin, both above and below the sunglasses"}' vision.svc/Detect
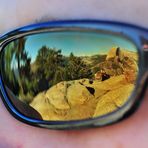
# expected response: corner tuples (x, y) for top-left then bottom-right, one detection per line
(0, 0), (148, 148)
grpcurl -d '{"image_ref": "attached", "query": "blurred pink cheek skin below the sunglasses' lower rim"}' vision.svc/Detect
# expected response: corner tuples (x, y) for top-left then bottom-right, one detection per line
(0, 88), (148, 148)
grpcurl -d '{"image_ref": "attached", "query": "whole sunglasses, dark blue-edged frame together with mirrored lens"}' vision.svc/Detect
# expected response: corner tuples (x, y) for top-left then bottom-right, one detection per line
(0, 20), (148, 129)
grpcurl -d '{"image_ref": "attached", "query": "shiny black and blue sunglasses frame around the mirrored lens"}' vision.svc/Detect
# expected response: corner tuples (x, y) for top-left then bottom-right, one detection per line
(0, 20), (148, 129)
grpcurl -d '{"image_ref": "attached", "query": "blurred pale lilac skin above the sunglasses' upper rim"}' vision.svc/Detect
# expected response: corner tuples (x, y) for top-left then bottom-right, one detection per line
(0, 0), (148, 32)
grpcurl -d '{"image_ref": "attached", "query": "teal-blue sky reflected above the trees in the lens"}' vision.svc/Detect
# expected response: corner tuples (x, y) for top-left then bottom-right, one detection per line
(25, 31), (136, 61)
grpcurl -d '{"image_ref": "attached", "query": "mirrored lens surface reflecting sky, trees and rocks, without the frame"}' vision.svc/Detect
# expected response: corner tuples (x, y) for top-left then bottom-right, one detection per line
(1, 31), (138, 120)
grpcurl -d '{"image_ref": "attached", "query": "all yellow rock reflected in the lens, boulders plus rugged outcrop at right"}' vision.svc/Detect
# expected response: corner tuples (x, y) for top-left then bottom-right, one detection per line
(30, 48), (138, 120)
